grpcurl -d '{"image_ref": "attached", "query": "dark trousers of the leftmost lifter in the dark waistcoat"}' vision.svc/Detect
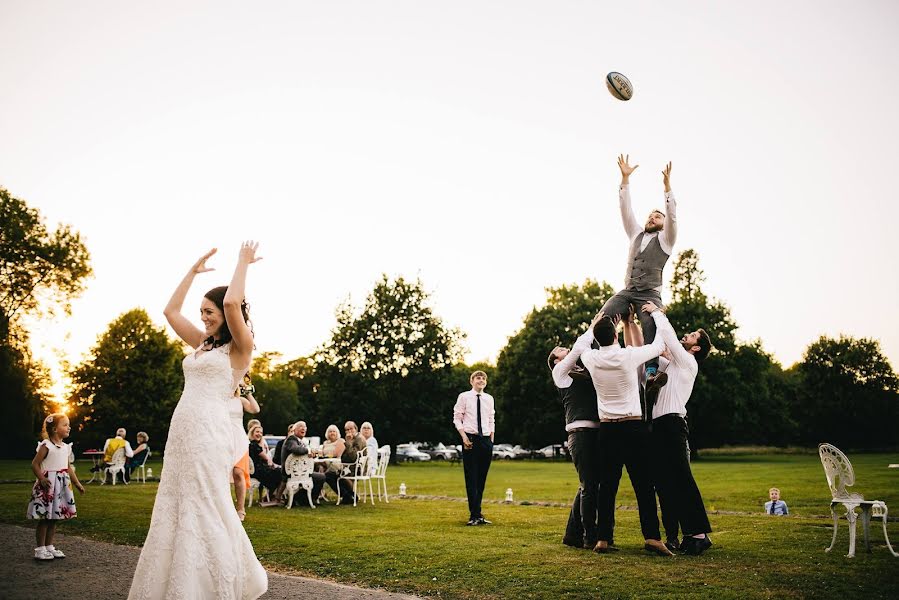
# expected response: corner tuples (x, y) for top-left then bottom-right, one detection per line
(565, 429), (599, 546)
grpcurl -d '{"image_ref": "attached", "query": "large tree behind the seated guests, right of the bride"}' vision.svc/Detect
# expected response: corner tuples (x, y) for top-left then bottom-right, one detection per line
(312, 275), (464, 443)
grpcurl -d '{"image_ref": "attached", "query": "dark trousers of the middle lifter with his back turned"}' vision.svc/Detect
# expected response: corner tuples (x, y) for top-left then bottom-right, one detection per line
(599, 421), (661, 542)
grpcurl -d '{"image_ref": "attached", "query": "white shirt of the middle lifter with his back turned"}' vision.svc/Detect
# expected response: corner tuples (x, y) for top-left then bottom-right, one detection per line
(581, 310), (665, 419)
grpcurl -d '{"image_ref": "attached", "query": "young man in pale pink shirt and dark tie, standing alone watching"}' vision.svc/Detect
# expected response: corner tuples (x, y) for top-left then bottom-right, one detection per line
(453, 371), (496, 525)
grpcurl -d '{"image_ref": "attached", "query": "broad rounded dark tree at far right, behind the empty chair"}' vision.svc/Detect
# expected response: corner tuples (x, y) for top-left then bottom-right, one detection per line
(793, 335), (899, 448)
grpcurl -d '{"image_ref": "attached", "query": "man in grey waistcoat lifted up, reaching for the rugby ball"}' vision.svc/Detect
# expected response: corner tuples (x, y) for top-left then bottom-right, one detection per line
(602, 155), (677, 389)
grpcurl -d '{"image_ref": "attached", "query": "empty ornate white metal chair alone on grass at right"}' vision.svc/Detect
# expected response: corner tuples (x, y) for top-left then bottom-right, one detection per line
(818, 444), (899, 558)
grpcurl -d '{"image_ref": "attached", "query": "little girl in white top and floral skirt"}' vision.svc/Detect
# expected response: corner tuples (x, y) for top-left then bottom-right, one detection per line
(28, 413), (84, 560)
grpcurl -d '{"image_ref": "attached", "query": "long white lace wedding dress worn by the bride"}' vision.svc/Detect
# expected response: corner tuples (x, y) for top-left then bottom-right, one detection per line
(128, 344), (268, 600)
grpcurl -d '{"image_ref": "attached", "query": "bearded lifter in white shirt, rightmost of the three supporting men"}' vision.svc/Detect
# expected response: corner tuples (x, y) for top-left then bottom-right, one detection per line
(643, 302), (712, 555)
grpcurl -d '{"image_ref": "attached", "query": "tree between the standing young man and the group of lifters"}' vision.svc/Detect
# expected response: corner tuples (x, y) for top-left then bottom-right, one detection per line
(494, 279), (615, 447)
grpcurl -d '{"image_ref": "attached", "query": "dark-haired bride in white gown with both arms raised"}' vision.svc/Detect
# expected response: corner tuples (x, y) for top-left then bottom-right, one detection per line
(128, 242), (268, 600)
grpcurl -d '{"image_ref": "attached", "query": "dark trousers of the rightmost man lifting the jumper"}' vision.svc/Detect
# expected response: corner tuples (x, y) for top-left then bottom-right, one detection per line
(652, 413), (712, 537)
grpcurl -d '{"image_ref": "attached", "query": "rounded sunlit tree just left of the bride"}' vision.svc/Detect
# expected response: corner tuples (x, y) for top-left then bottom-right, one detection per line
(70, 308), (184, 446)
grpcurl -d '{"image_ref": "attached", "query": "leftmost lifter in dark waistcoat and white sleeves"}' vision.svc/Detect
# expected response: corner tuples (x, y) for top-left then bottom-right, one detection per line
(547, 311), (602, 550)
